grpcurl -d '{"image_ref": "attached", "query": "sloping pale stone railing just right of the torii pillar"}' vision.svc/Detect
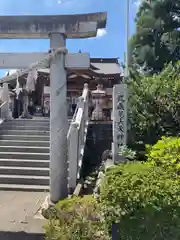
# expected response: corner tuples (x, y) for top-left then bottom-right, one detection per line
(67, 84), (89, 191)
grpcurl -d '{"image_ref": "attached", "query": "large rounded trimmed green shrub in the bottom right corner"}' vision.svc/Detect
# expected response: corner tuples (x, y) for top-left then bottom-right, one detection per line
(100, 162), (180, 240)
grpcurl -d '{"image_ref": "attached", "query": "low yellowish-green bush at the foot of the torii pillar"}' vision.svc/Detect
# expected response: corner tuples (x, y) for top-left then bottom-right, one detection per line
(45, 196), (106, 240)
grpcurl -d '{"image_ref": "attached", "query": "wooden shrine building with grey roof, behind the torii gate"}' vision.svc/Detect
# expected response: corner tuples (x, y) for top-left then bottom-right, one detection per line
(5, 58), (122, 119)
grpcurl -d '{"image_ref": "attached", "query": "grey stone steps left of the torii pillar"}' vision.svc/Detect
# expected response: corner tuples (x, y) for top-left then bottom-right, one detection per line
(0, 118), (50, 191)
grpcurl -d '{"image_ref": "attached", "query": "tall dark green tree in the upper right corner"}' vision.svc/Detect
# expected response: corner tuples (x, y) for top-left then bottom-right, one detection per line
(129, 0), (180, 73)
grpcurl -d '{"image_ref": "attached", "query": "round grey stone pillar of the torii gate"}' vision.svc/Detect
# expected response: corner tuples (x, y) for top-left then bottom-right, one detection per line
(50, 33), (68, 202)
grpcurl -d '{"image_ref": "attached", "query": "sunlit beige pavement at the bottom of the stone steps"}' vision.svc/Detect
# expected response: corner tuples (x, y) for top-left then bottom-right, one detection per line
(0, 191), (47, 240)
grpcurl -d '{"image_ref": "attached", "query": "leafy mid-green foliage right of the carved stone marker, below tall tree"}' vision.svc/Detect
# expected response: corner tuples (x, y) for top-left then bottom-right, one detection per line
(128, 62), (180, 144)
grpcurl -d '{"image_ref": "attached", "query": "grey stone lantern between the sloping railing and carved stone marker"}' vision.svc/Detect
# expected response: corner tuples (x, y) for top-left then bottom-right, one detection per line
(91, 84), (106, 120)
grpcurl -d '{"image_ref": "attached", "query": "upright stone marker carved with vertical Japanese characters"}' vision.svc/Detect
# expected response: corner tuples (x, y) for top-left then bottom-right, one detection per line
(112, 84), (128, 162)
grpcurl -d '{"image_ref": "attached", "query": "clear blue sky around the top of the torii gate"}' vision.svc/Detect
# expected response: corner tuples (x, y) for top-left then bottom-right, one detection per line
(0, 0), (137, 76)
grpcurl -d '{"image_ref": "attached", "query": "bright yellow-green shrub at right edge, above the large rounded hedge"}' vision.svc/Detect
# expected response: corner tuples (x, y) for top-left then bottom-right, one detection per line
(147, 137), (180, 172)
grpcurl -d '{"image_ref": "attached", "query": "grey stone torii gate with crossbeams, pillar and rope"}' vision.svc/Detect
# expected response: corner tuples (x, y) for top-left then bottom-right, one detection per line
(0, 12), (107, 202)
